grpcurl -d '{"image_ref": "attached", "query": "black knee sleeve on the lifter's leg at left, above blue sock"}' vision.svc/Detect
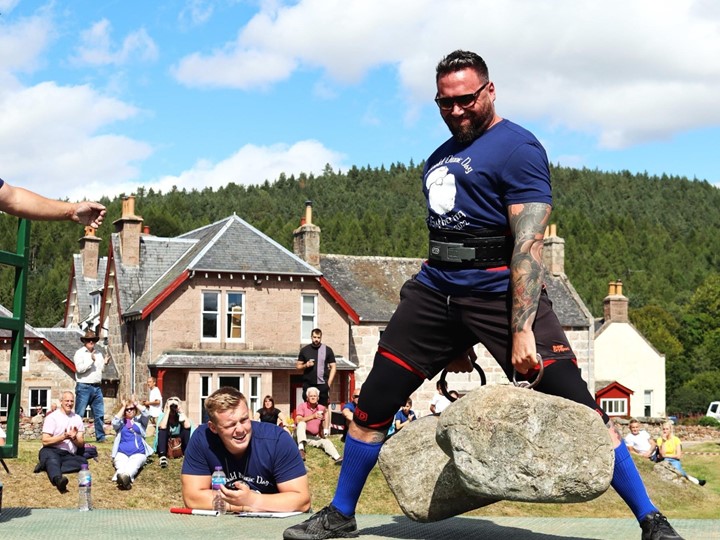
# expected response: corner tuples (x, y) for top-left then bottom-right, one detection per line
(353, 352), (423, 431)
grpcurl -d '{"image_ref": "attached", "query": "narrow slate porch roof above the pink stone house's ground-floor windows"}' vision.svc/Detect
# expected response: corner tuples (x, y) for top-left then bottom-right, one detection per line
(149, 351), (357, 371)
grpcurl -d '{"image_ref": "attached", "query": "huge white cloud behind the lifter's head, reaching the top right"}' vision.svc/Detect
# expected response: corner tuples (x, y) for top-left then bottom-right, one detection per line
(174, 0), (720, 149)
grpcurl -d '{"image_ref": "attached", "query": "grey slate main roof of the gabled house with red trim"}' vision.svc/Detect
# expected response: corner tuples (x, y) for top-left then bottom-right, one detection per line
(120, 215), (321, 316)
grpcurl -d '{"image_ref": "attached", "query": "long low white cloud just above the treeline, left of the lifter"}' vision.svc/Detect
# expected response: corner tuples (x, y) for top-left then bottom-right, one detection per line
(71, 140), (345, 200)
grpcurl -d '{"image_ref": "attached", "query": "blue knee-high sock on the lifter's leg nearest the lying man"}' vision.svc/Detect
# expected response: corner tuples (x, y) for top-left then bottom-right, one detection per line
(332, 435), (382, 517)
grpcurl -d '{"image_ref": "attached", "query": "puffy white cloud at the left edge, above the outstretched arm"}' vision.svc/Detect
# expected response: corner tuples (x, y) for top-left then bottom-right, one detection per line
(0, 82), (152, 198)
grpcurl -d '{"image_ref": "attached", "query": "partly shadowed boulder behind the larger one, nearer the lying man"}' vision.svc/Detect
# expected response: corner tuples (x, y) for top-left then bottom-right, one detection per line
(379, 416), (495, 522)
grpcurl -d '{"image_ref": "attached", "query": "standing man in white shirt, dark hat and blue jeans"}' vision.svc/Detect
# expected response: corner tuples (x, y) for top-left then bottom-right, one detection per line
(73, 330), (105, 443)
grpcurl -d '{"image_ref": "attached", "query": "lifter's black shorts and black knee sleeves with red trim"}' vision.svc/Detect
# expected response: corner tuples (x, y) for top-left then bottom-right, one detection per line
(355, 280), (608, 429)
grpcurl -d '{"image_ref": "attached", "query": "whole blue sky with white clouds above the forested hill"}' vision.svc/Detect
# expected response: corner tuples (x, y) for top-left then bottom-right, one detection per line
(0, 0), (720, 200)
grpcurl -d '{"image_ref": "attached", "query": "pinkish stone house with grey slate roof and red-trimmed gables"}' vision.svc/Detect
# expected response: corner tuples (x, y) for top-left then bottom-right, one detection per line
(65, 197), (355, 424)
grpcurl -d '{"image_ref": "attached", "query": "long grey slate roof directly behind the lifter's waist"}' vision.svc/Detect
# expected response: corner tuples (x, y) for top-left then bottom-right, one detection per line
(320, 255), (591, 328)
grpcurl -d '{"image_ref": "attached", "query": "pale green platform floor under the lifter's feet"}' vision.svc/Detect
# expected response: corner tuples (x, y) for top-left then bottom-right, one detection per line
(0, 508), (720, 540)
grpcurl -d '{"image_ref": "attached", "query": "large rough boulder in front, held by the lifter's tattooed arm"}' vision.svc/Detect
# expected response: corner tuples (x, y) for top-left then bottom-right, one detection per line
(437, 386), (614, 502)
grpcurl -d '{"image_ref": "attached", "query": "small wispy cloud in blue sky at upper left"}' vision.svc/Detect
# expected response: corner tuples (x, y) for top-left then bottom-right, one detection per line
(72, 19), (158, 66)
